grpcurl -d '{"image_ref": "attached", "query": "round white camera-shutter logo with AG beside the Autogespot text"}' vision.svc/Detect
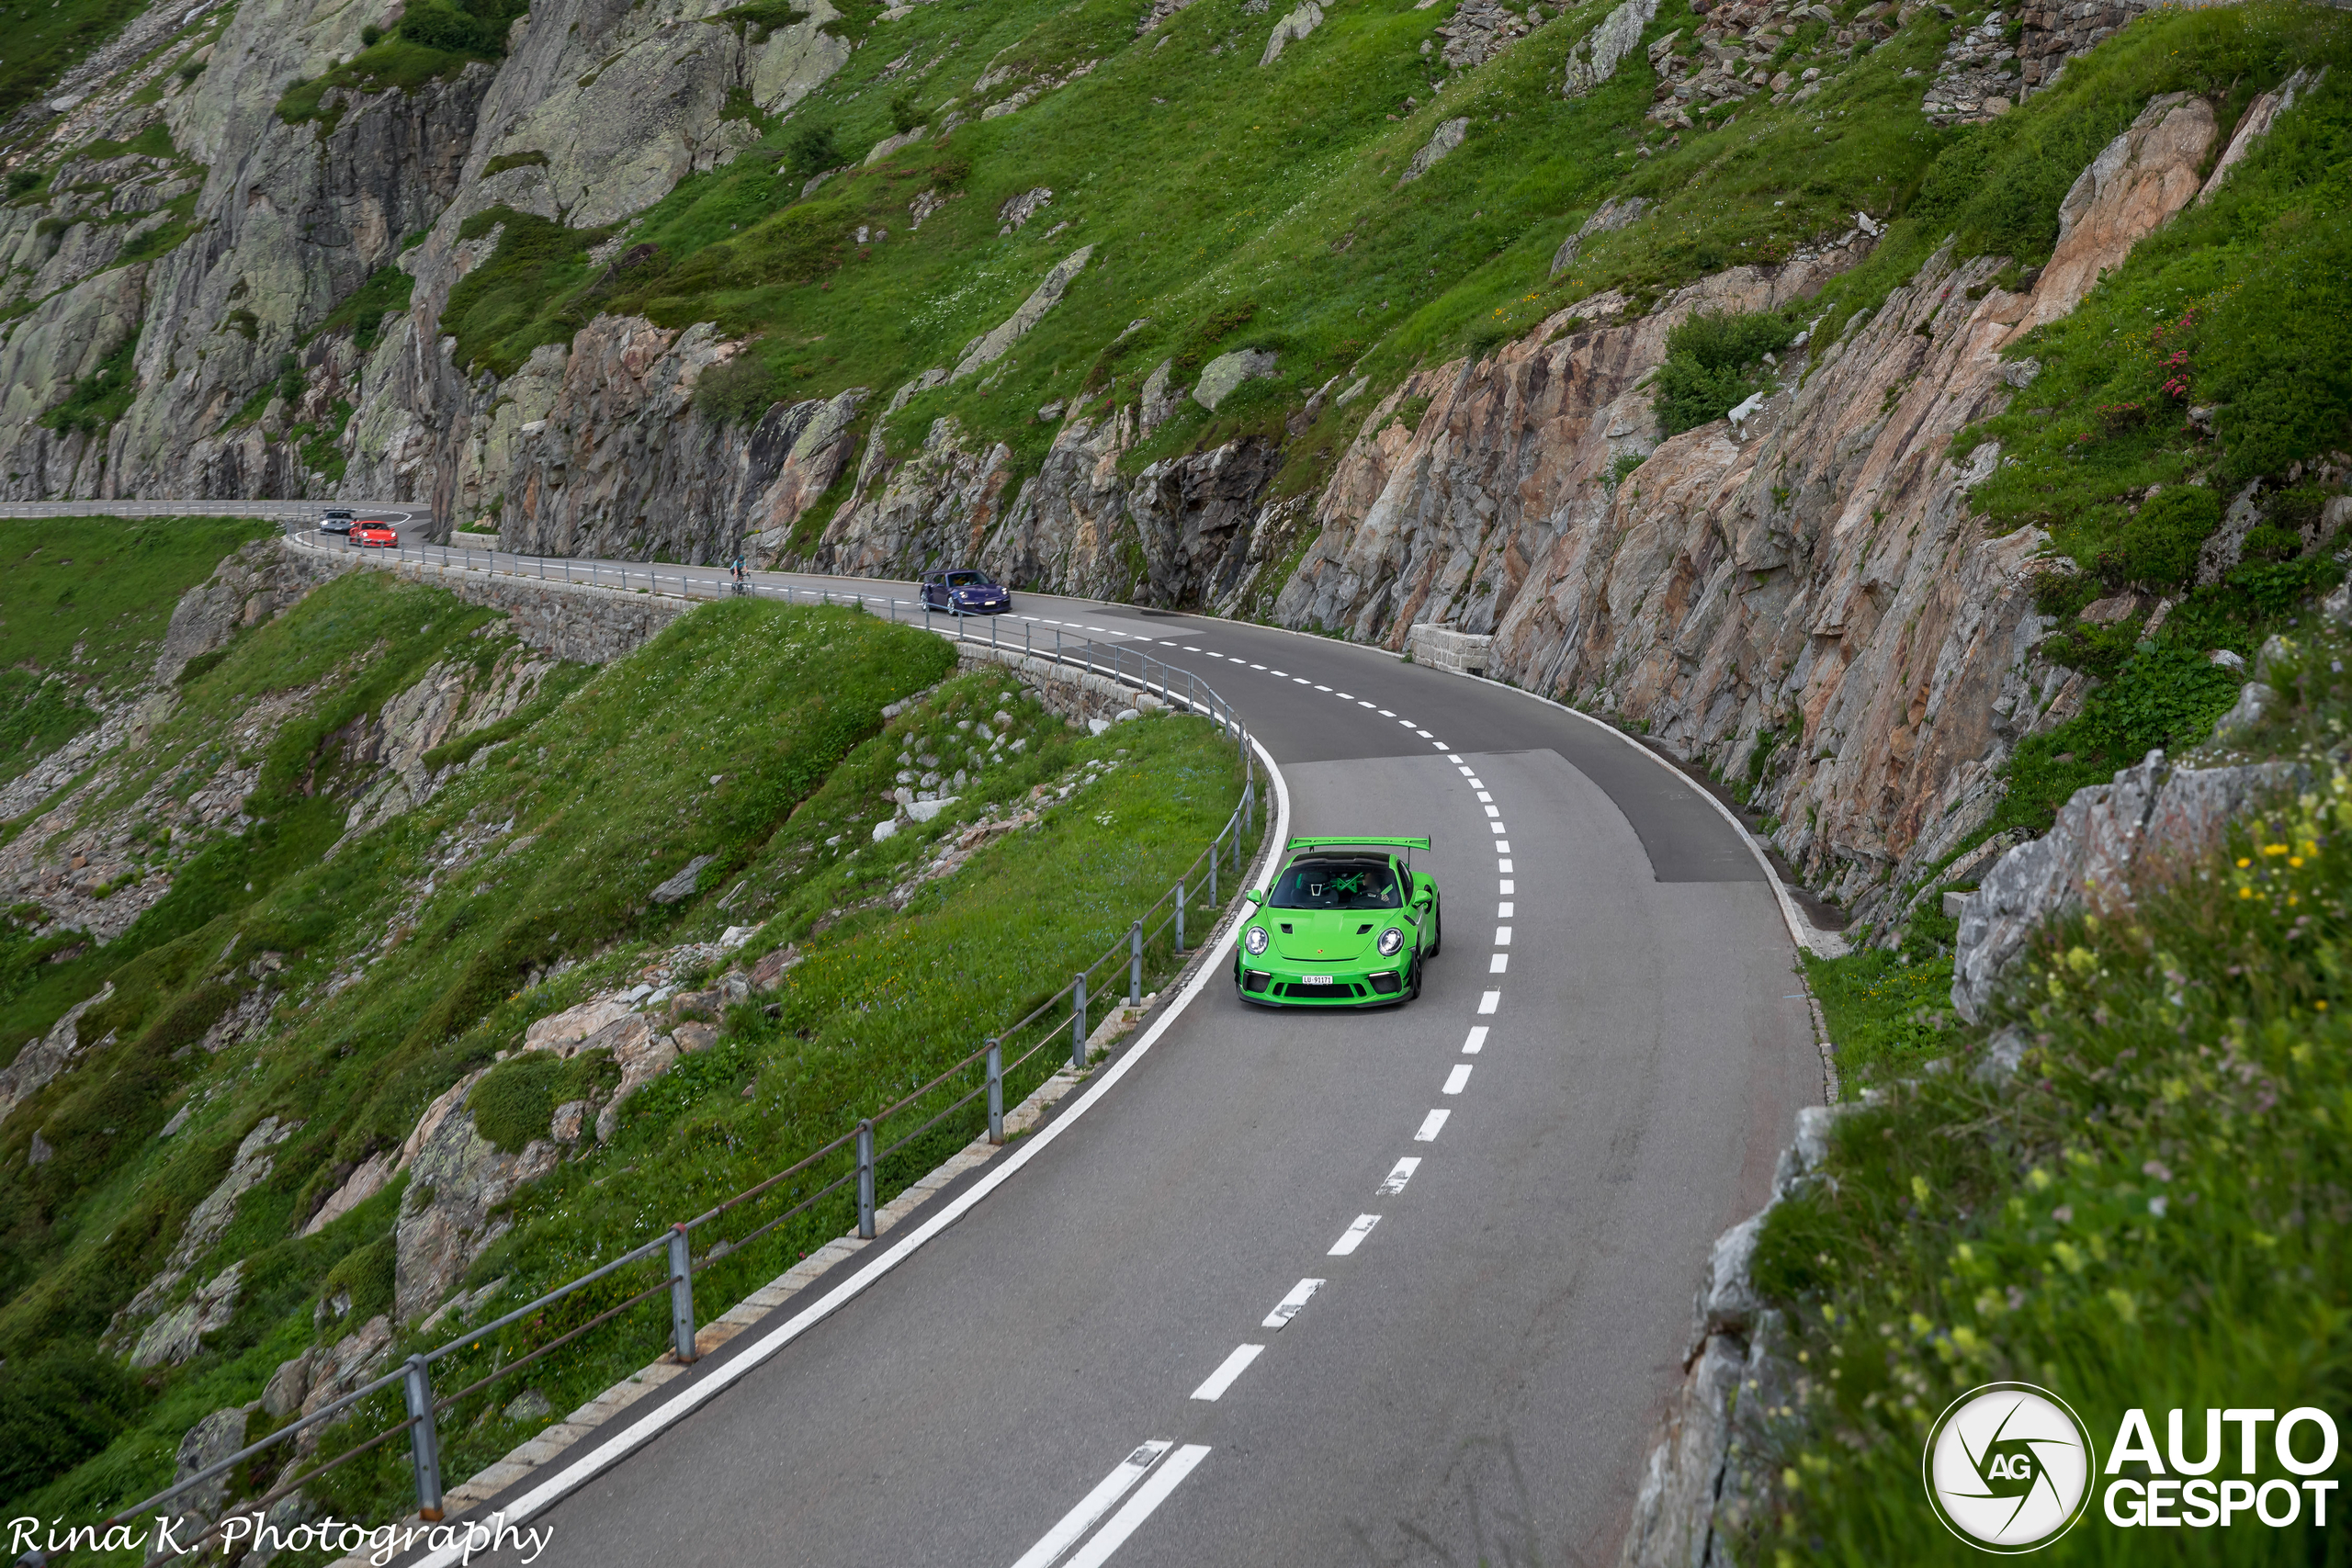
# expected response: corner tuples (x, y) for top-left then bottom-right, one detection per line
(1922, 1382), (2098, 1554)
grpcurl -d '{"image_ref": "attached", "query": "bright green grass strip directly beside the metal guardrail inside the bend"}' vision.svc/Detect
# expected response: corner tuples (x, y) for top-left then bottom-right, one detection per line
(303, 674), (1239, 1517)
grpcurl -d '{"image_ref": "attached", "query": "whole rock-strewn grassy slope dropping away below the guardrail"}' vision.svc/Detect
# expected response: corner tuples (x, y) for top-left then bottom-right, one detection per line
(0, 576), (1238, 1512)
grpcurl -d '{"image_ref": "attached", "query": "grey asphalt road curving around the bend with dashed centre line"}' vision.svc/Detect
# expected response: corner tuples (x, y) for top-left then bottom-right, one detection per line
(299, 531), (1820, 1568)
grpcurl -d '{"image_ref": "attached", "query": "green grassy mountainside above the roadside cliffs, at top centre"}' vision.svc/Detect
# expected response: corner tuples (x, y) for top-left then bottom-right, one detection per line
(452, 0), (1943, 510)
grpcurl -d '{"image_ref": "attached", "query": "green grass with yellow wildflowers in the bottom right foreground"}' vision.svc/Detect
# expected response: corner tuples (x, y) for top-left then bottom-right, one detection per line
(1738, 773), (2352, 1565)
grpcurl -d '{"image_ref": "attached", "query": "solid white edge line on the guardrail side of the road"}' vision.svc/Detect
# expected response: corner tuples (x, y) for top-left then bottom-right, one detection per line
(401, 736), (1291, 1568)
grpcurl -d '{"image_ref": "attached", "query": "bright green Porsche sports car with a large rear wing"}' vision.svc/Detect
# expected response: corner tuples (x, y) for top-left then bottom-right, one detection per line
(1232, 840), (1437, 1006)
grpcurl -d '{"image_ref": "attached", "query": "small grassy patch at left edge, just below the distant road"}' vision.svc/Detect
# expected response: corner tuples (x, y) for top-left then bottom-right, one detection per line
(0, 517), (268, 783)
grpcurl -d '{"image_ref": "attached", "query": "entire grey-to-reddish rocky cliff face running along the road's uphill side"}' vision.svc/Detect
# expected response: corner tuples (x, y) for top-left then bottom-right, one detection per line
(0, 0), (2314, 917)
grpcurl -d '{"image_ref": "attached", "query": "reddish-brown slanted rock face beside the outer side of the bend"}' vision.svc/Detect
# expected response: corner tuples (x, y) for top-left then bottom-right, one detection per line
(1277, 98), (2216, 915)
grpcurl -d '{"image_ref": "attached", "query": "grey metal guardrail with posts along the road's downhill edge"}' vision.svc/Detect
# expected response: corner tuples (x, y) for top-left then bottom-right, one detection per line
(101, 541), (1259, 1550)
